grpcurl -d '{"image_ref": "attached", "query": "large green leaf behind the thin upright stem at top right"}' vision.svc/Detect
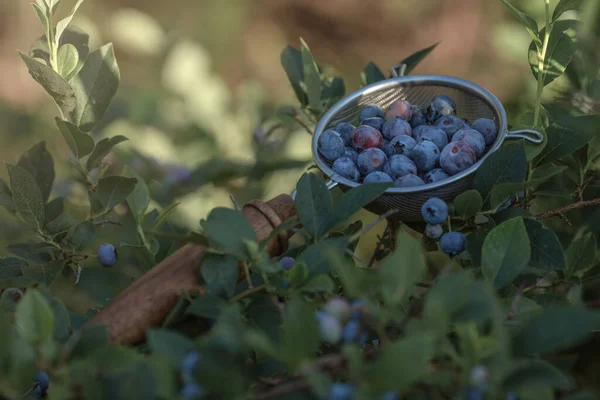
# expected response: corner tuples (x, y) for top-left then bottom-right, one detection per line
(528, 20), (578, 86)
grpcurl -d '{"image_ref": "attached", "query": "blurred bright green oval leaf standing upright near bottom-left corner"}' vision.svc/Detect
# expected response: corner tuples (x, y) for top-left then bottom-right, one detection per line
(15, 290), (54, 343)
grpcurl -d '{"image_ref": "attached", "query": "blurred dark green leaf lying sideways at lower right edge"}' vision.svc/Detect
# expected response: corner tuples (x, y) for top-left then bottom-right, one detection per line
(512, 305), (597, 355)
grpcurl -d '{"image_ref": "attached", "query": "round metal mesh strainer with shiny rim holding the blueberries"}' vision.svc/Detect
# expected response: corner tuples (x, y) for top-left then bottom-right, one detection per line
(304, 65), (543, 222)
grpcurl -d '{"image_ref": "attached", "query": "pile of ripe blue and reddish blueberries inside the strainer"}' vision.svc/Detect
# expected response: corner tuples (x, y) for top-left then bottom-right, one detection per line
(318, 95), (498, 187)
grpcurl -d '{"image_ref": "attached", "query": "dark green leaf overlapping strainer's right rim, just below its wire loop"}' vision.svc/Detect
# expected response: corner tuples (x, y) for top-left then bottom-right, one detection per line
(475, 140), (527, 207)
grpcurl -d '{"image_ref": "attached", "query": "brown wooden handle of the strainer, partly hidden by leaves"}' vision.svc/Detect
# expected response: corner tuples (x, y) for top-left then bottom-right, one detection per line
(87, 195), (296, 344)
